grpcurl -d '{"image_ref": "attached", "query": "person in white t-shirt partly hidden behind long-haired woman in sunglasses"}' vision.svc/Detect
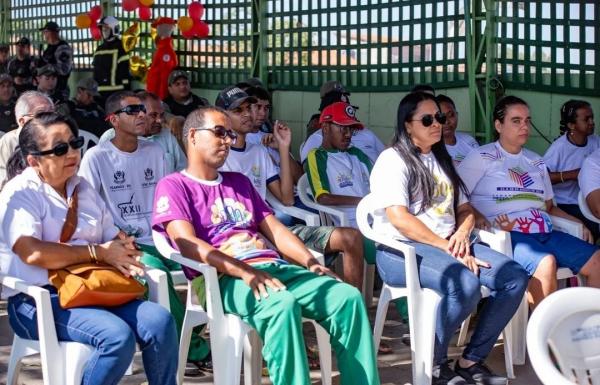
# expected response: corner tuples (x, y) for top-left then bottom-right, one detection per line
(435, 95), (479, 167)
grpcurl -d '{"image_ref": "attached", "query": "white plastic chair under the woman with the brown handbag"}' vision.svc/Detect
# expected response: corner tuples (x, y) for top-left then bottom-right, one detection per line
(0, 269), (169, 385)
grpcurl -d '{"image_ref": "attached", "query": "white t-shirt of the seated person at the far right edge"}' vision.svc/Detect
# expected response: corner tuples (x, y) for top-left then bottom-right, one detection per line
(544, 134), (600, 204)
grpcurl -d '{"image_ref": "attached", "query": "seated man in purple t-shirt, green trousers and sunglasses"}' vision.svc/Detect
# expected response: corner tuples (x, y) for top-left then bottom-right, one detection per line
(153, 107), (379, 385)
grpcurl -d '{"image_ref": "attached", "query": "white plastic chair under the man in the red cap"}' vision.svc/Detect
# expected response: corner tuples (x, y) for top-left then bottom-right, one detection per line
(298, 174), (375, 308)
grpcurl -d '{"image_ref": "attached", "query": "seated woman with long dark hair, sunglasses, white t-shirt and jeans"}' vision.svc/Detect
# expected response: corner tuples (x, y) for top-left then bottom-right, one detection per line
(370, 92), (527, 384)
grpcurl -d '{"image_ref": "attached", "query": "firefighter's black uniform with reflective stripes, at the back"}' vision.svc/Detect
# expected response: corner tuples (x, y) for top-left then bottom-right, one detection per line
(92, 38), (131, 100)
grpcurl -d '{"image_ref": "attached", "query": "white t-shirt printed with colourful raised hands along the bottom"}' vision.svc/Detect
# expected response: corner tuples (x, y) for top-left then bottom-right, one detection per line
(458, 142), (554, 233)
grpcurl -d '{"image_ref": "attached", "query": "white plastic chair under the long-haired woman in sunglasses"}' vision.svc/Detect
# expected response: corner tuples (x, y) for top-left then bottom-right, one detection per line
(356, 194), (441, 385)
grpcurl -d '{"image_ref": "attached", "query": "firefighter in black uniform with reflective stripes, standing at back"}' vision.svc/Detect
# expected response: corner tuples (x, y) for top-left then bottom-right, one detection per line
(93, 16), (131, 102)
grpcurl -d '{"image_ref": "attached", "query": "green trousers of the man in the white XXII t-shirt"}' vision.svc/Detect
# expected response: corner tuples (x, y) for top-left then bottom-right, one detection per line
(138, 244), (210, 361)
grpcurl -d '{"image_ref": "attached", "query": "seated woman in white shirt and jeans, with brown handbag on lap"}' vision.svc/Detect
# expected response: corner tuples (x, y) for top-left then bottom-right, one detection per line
(0, 113), (178, 385)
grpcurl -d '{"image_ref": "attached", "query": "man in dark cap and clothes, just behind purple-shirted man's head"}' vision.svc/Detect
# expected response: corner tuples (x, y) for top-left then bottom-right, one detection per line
(164, 68), (210, 118)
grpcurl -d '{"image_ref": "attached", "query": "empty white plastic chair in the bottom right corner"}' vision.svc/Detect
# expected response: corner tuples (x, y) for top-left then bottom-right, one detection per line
(527, 287), (600, 385)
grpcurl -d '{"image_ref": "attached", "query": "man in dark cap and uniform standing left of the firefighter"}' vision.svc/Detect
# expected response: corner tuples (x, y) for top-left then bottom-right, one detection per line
(37, 21), (73, 100)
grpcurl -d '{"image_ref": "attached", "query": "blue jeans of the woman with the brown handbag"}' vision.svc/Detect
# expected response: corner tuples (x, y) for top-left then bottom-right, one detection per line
(8, 286), (178, 385)
